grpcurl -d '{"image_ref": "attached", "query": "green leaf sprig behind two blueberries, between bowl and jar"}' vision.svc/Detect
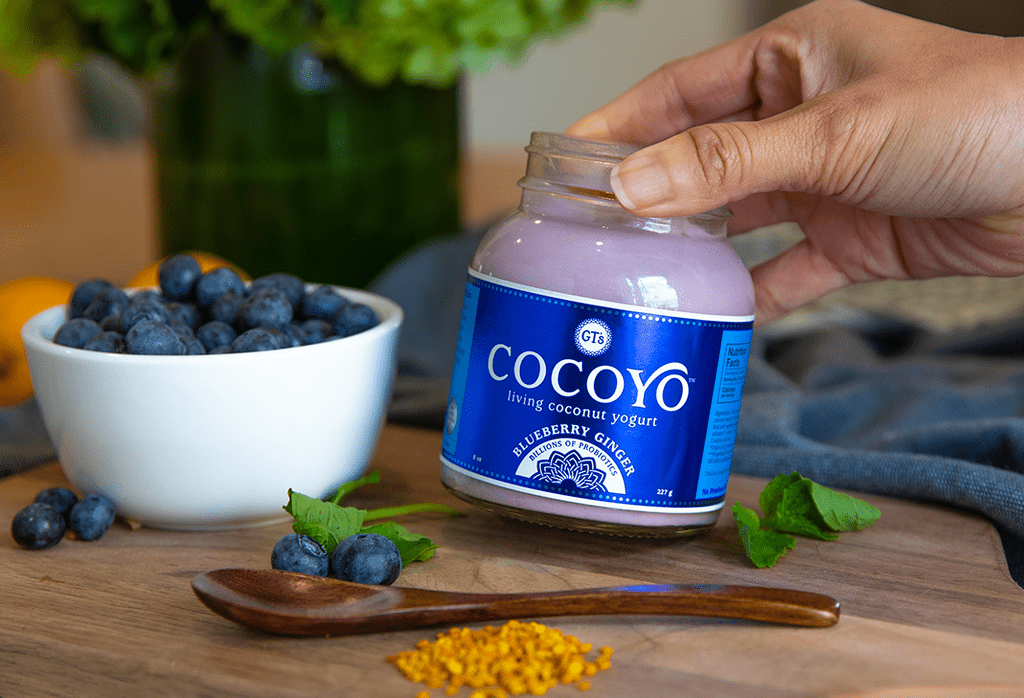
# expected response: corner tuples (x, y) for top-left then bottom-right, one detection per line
(285, 472), (462, 568)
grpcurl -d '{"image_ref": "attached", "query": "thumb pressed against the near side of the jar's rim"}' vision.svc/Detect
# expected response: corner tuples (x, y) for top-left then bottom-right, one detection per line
(611, 107), (822, 216)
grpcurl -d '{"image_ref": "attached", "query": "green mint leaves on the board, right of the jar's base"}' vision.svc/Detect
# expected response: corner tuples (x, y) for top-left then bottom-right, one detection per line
(732, 472), (882, 567)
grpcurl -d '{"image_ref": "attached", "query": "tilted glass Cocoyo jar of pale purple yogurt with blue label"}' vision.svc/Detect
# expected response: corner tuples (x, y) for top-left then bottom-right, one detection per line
(440, 128), (754, 536)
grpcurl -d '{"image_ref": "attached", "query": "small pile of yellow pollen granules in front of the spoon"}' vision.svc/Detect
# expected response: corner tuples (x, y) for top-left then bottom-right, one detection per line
(387, 620), (611, 698)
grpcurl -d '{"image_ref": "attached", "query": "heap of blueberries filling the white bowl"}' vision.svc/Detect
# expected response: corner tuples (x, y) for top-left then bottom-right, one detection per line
(53, 255), (379, 355)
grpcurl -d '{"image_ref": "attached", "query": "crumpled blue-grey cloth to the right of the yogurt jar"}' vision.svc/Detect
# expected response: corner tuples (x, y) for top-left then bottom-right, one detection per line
(732, 318), (1024, 586)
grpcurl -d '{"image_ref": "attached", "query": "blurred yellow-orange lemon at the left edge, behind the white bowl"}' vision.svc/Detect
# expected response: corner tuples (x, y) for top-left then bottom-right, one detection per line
(0, 276), (75, 405)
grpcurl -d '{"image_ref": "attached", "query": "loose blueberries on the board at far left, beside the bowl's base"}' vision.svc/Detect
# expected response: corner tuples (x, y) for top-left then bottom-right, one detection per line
(10, 487), (114, 551)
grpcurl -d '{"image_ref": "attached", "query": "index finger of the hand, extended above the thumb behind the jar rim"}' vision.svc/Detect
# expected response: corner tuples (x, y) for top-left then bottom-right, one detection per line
(566, 32), (774, 145)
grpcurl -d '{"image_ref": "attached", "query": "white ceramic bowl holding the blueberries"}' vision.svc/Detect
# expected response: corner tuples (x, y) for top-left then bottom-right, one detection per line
(22, 289), (402, 530)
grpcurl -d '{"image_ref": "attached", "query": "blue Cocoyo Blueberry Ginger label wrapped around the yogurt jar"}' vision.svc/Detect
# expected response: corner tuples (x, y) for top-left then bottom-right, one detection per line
(441, 271), (753, 512)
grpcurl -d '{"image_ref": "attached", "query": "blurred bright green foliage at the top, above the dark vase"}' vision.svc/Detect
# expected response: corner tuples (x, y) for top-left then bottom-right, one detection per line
(0, 0), (635, 86)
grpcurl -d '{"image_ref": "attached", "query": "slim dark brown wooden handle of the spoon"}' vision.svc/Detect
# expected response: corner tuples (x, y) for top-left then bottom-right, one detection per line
(409, 584), (840, 627)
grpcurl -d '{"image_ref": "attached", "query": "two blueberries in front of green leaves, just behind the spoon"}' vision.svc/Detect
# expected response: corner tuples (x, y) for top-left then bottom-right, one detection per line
(270, 533), (401, 585)
